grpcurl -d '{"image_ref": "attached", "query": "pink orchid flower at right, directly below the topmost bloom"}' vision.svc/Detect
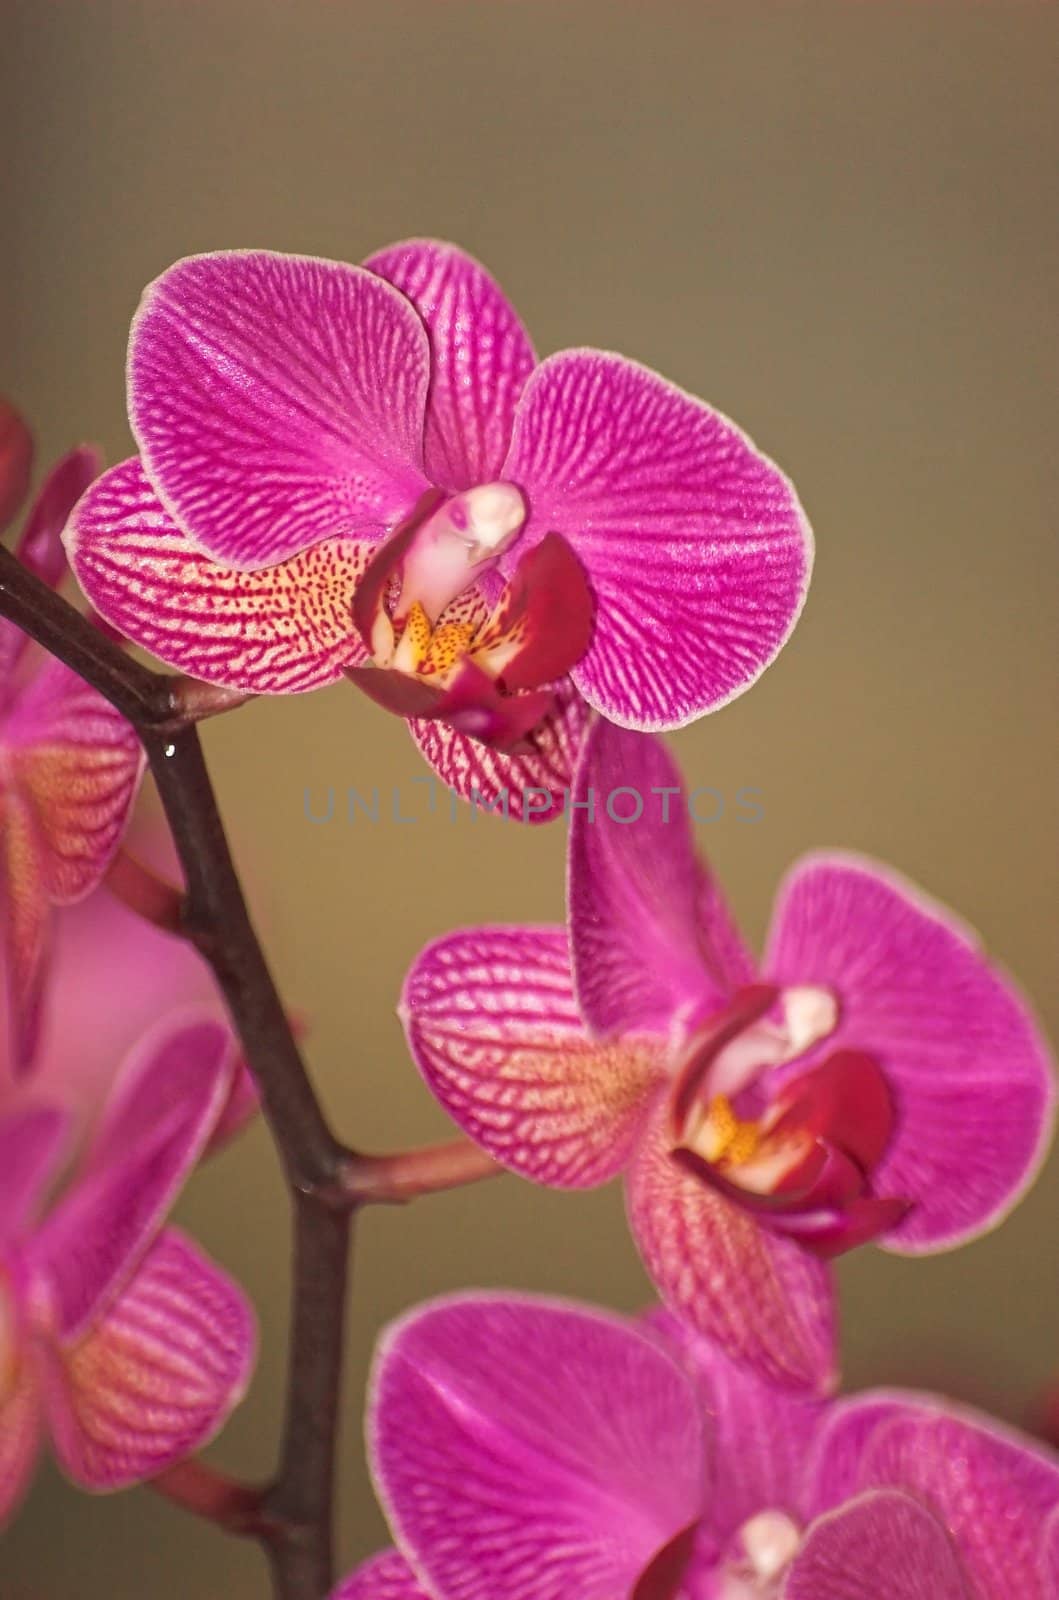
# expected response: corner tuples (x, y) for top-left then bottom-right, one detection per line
(402, 722), (1054, 1387)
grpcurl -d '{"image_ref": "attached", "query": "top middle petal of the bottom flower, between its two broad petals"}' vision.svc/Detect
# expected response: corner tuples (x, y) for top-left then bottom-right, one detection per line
(646, 1307), (827, 1549)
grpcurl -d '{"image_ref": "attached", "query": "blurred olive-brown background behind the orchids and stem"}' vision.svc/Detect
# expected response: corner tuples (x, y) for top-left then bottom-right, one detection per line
(0, 0), (1059, 1600)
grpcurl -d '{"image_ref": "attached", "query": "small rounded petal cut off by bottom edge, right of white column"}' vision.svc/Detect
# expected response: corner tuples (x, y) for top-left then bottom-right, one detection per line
(782, 1490), (972, 1600)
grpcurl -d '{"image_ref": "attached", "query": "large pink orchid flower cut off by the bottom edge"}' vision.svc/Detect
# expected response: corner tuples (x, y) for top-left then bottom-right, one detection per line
(333, 1294), (1059, 1600)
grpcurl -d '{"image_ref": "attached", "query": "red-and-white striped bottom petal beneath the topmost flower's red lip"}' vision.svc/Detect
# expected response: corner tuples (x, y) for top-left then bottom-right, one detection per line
(408, 683), (590, 822)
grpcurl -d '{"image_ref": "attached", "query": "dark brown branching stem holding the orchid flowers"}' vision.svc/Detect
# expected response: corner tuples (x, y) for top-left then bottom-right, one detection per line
(0, 549), (505, 1600)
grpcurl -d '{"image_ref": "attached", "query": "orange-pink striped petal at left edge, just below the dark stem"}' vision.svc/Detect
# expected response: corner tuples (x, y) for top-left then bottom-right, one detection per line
(3, 658), (144, 906)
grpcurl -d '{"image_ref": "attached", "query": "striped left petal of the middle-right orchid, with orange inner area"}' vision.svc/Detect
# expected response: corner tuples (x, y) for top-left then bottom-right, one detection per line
(400, 926), (662, 1189)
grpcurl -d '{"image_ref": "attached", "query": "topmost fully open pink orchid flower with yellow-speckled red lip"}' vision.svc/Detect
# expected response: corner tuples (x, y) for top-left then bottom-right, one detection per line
(67, 240), (811, 819)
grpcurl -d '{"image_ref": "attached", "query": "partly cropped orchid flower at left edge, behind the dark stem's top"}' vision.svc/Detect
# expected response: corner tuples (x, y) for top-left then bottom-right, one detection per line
(0, 406), (144, 1072)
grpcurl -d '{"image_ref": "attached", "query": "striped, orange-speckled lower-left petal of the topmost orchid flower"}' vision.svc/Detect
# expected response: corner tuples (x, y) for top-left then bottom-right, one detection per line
(66, 459), (371, 694)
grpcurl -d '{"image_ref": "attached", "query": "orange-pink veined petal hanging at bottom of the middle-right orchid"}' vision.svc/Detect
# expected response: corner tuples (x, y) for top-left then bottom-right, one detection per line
(627, 1099), (835, 1392)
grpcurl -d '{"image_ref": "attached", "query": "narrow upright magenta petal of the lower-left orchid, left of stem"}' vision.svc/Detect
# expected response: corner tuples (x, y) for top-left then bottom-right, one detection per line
(26, 1022), (235, 1341)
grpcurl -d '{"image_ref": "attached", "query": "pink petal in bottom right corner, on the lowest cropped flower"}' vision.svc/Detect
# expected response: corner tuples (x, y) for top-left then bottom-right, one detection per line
(813, 1390), (1059, 1600)
